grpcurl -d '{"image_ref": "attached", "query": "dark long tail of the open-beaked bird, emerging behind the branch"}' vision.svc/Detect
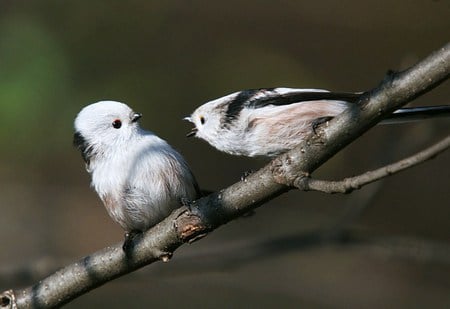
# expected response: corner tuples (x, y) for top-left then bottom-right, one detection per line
(380, 105), (450, 124)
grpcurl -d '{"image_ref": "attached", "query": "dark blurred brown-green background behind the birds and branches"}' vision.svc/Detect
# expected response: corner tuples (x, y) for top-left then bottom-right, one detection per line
(0, 0), (450, 308)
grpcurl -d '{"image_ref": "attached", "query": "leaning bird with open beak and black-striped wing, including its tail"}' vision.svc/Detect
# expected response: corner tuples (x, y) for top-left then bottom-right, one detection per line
(184, 87), (450, 158)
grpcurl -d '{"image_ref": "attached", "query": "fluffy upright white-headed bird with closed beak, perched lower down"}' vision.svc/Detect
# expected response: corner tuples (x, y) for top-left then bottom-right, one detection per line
(73, 101), (200, 252)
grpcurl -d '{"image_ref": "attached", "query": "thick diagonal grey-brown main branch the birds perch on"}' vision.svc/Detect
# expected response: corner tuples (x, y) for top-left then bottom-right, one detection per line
(0, 44), (450, 308)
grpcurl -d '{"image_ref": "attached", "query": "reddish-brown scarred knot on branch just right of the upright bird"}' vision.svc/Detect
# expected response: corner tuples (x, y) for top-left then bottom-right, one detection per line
(174, 204), (212, 243)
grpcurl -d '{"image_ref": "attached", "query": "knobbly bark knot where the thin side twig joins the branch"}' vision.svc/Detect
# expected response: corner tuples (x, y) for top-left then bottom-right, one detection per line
(270, 155), (309, 187)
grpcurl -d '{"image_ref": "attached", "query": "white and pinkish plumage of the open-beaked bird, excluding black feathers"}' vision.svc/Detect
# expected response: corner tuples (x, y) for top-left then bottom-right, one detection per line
(189, 88), (348, 157)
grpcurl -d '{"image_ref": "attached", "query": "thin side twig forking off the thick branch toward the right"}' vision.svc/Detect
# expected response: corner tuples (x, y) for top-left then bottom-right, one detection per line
(294, 136), (450, 193)
